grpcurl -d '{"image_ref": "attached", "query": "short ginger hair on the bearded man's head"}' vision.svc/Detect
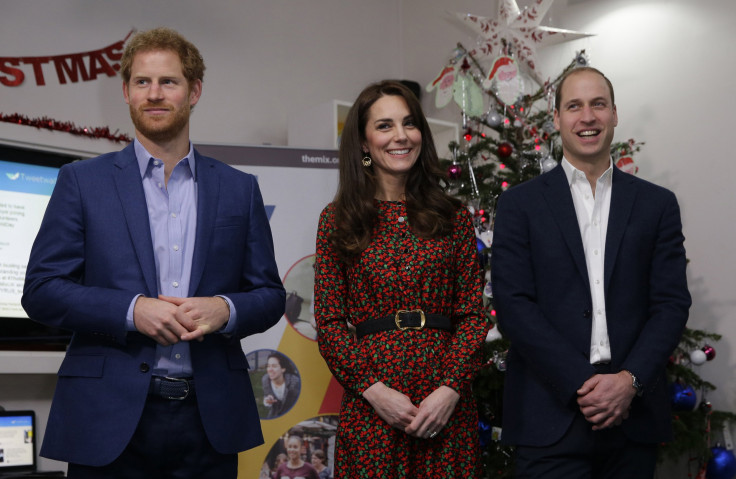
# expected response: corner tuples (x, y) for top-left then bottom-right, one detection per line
(120, 27), (205, 87)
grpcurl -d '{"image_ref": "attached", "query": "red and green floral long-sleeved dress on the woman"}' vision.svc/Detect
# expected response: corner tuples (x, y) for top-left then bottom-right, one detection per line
(315, 201), (489, 479)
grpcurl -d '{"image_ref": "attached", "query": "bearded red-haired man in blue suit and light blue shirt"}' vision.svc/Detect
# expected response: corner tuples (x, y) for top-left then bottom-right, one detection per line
(23, 28), (285, 479)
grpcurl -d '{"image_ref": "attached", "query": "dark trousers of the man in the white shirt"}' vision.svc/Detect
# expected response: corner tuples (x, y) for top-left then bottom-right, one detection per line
(514, 414), (657, 479)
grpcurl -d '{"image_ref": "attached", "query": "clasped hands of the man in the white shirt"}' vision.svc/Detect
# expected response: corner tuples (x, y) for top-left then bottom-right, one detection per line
(577, 371), (636, 431)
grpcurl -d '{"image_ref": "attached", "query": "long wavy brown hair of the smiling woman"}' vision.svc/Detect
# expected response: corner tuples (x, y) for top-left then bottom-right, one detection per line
(330, 80), (462, 260)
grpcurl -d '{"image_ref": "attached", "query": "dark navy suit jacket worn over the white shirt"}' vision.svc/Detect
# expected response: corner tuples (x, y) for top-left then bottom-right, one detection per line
(491, 166), (690, 446)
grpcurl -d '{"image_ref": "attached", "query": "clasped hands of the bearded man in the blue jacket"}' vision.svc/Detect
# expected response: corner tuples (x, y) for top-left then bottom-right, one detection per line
(133, 296), (230, 346)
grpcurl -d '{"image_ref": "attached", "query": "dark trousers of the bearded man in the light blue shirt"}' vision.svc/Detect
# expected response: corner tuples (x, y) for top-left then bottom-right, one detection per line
(67, 396), (238, 479)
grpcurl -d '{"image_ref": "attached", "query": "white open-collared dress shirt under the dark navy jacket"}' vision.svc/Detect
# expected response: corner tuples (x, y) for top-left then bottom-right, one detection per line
(562, 158), (613, 364)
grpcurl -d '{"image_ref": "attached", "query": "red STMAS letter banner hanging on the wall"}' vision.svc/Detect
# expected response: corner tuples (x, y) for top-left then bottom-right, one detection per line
(0, 34), (130, 87)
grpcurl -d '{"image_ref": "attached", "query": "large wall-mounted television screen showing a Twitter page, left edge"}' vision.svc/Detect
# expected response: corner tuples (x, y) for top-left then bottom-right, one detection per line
(0, 144), (81, 350)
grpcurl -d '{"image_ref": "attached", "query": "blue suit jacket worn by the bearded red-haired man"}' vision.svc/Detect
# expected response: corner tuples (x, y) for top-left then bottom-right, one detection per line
(22, 144), (285, 466)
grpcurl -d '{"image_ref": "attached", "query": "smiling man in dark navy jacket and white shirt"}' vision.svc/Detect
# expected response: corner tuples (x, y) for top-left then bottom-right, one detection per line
(491, 68), (691, 479)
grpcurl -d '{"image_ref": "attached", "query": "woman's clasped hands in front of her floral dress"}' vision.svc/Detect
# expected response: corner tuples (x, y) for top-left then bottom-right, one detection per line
(363, 382), (460, 438)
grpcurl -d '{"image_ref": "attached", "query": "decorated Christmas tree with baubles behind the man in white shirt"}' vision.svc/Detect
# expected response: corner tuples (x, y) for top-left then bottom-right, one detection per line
(427, 17), (736, 479)
